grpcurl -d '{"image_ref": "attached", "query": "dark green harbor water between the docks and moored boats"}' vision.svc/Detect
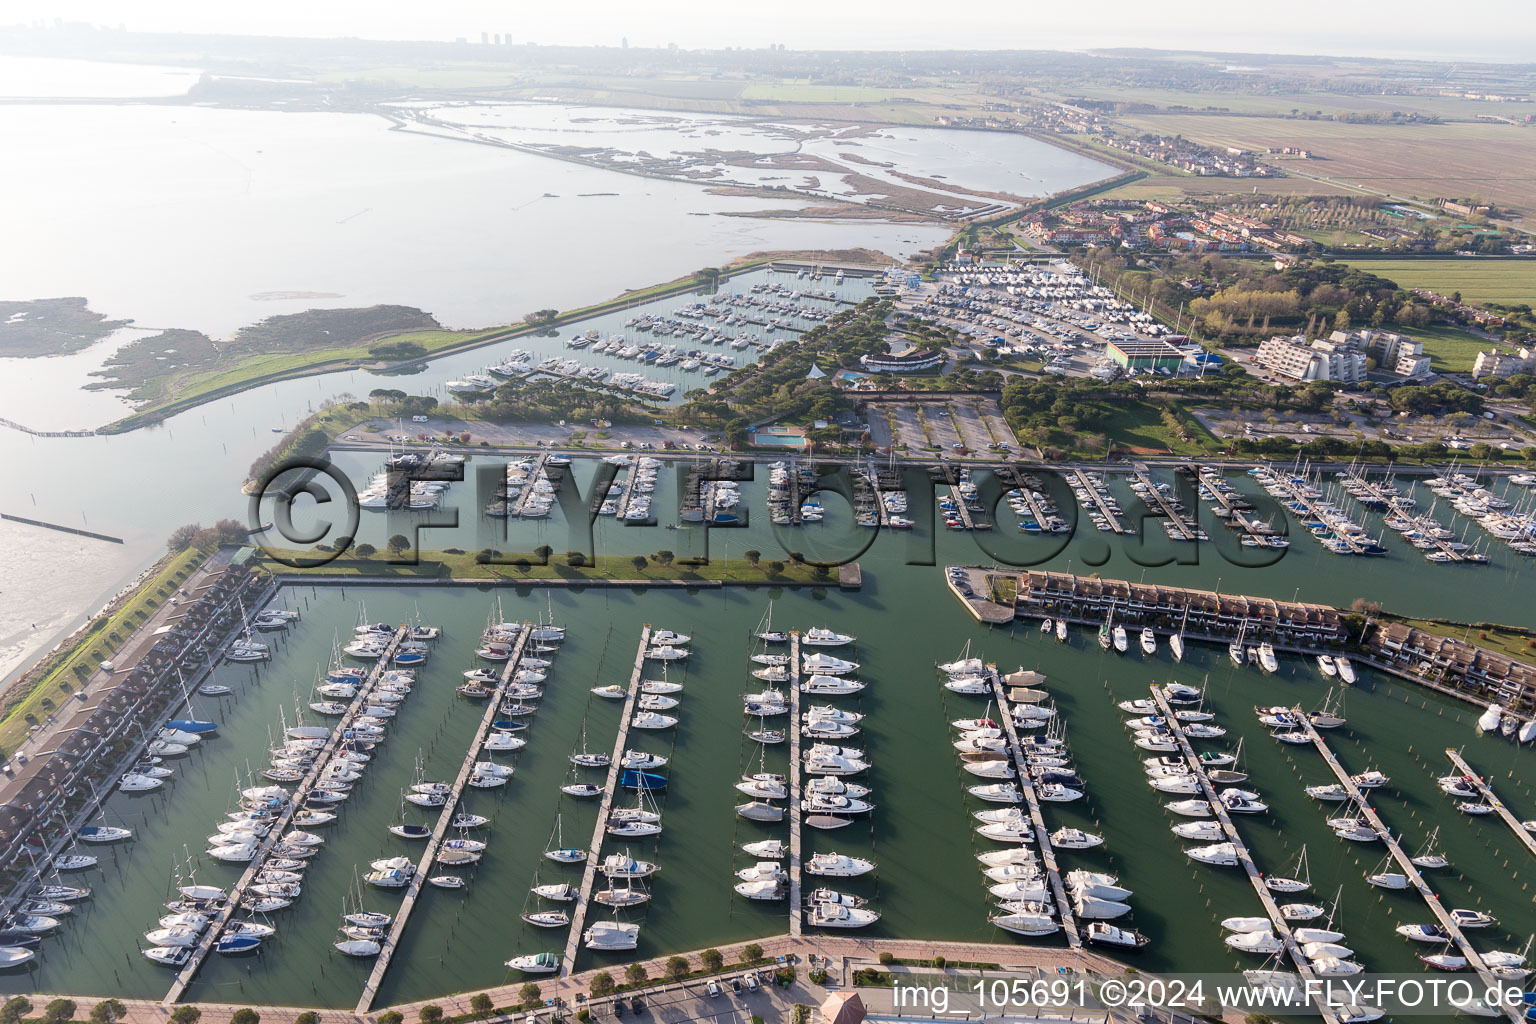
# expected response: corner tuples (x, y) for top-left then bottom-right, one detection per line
(0, 456), (1536, 1007)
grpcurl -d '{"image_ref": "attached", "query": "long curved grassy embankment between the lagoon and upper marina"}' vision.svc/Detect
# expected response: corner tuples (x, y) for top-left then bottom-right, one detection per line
(101, 256), (771, 433)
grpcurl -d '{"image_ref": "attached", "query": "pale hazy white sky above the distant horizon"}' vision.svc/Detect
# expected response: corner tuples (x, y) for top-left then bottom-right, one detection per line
(9, 0), (1536, 61)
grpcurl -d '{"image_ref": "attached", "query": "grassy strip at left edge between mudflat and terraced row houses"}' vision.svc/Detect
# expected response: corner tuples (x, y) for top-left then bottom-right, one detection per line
(0, 548), (209, 752)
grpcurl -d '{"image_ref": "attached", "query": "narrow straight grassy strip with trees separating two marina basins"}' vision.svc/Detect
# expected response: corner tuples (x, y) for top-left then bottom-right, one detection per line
(250, 550), (837, 586)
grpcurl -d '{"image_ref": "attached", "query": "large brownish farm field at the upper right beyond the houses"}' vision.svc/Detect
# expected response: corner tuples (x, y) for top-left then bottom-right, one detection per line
(1129, 114), (1536, 210)
